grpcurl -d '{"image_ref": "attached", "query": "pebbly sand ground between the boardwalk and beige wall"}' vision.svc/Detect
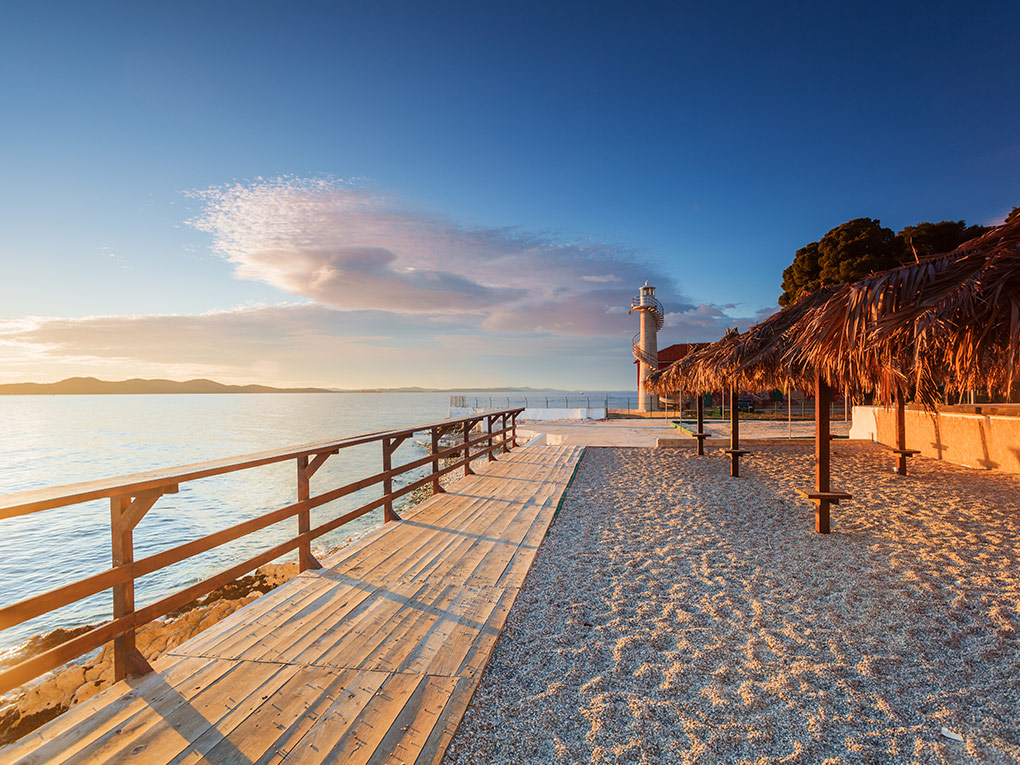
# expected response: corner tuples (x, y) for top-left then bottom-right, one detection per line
(445, 443), (1020, 764)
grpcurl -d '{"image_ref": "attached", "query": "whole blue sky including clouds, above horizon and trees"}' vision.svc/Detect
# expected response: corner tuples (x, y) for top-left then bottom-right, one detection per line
(0, 2), (1020, 389)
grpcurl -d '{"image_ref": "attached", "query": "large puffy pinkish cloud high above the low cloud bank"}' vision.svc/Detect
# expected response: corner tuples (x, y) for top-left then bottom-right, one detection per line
(191, 179), (685, 335)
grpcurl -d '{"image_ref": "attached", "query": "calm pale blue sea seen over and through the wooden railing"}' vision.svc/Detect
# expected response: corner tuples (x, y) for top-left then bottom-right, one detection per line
(0, 392), (633, 653)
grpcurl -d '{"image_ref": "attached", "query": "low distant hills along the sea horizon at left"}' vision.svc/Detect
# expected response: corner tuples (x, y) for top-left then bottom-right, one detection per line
(0, 377), (571, 396)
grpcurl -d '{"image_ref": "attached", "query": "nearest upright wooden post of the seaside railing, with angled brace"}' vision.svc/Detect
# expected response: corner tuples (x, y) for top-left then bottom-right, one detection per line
(110, 491), (162, 680)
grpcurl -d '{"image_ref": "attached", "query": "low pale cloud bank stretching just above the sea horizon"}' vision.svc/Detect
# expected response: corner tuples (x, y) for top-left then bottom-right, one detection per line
(0, 303), (629, 388)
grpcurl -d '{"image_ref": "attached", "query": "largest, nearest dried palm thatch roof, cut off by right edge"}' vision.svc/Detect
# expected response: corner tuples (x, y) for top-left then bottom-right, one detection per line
(784, 220), (1020, 401)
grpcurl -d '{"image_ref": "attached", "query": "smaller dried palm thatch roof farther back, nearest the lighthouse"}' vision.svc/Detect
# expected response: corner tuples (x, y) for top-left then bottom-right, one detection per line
(650, 288), (835, 394)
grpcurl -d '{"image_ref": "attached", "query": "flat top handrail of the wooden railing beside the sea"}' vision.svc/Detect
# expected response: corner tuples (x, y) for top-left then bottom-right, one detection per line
(0, 407), (524, 519)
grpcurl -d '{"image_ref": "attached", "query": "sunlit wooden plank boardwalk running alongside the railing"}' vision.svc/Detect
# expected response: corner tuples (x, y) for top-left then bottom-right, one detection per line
(0, 446), (581, 763)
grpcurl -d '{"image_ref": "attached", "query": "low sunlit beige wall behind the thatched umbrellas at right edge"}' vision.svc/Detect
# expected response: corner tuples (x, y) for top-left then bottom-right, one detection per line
(851, 406), (1020, 473)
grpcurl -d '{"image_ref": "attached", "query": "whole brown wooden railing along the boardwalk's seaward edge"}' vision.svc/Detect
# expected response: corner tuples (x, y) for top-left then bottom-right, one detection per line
(0, 408), (523, 694)
